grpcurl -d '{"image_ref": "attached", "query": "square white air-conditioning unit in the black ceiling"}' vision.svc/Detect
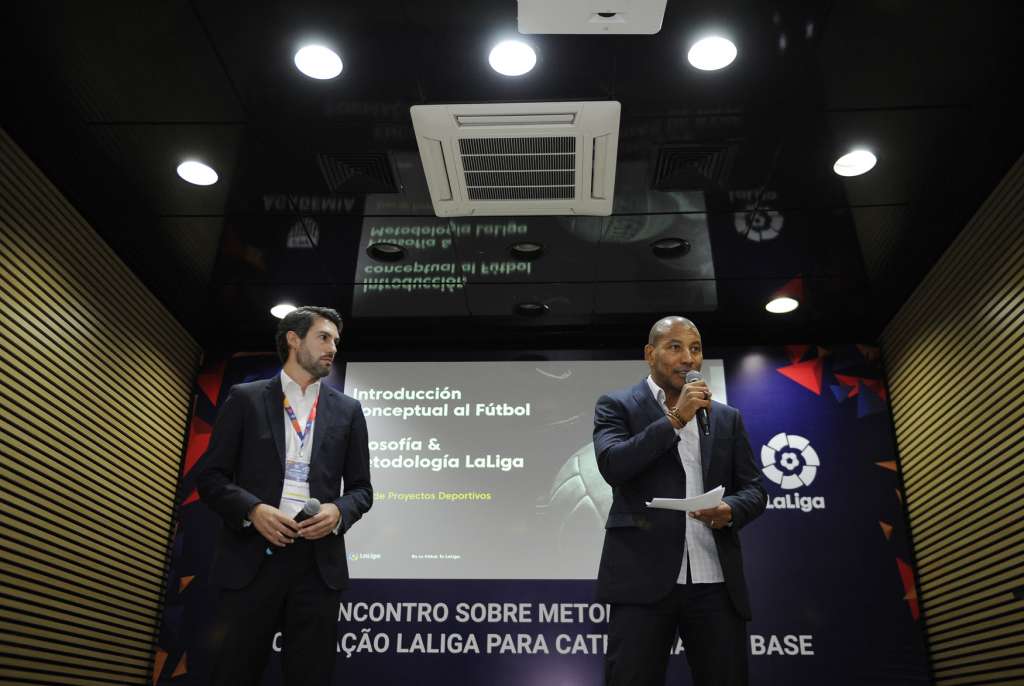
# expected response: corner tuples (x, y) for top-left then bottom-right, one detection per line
(411, 100), (621, 217)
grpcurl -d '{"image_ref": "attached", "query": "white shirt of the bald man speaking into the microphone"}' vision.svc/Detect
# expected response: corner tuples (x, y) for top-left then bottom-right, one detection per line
(647, 376), (725, 584)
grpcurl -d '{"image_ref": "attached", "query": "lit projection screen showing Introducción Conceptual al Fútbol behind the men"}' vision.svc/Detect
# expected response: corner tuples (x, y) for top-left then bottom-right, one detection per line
(345, 360), (727, 580)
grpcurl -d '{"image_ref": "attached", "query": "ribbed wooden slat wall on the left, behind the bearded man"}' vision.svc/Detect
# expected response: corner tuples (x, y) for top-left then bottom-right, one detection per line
(0, 130), (200, 685)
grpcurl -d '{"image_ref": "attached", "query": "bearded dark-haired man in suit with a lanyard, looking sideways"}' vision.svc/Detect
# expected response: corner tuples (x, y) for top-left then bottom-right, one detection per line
(199, 307), (373, 686)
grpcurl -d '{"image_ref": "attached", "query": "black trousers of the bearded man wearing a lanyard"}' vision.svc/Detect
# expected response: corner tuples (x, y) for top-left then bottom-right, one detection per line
(210, 539), (341, 686)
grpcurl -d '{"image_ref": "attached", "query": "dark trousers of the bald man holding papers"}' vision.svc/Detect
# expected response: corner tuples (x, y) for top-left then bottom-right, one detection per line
(604, 584), (746, 686)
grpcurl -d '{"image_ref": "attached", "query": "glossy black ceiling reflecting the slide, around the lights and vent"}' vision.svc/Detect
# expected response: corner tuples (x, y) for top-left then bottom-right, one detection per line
(3, 0), (1024, 354)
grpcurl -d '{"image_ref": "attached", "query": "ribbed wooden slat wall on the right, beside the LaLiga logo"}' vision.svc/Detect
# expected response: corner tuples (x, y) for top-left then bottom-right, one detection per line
(882, 153), (1024, 684)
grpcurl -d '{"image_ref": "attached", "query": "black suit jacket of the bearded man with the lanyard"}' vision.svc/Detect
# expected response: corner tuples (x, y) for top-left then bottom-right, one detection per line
(198, 374), (374, 589)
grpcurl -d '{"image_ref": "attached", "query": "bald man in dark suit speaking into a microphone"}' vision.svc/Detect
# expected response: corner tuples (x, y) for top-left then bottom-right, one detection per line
(594, 316), (767, 686)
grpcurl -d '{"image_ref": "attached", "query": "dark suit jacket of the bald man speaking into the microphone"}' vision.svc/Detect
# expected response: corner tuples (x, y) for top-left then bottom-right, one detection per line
(594, 380), (767, 619)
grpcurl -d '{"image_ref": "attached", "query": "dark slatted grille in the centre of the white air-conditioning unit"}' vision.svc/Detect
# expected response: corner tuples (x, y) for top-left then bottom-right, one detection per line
(459, 136), (575, 200)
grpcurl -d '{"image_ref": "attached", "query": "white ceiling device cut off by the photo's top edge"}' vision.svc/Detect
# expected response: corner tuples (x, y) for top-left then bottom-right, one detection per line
(519, 0), (668, 36)
